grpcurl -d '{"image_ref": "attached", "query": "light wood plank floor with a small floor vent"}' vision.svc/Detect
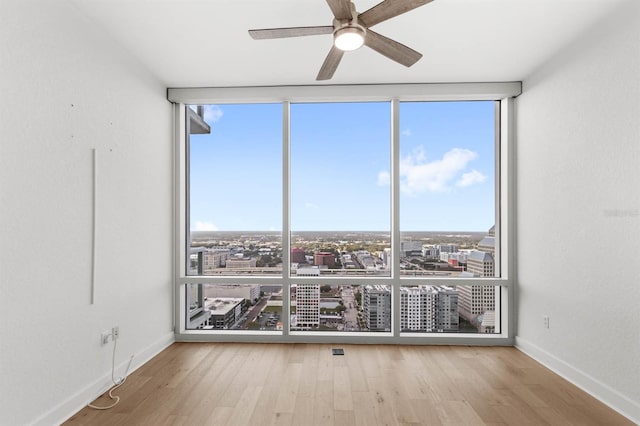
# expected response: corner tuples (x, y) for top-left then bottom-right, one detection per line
(65, 343), (632, 426)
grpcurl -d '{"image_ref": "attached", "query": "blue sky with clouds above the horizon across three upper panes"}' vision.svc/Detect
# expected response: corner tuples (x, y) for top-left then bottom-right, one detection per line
(190, 102), (494, 231)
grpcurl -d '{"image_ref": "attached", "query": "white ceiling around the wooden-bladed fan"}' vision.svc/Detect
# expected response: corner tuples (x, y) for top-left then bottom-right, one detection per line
(71, 0), (624, 87)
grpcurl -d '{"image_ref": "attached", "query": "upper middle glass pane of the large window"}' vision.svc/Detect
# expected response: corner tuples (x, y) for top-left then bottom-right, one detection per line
(290, 102), (391, 276)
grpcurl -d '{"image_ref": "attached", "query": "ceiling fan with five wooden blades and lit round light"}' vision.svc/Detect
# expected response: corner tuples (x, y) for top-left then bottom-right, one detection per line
(249, 0), (433, 80)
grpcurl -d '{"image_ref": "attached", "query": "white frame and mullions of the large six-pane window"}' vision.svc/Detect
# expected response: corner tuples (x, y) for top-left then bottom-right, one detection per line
(167, 82), (522, 345)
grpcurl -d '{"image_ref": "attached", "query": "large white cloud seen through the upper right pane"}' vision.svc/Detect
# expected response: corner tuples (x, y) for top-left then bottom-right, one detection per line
(378, 145), (486, 195)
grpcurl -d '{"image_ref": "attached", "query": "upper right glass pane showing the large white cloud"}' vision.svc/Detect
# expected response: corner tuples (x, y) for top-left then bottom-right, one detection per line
(400, 101), (499, 278)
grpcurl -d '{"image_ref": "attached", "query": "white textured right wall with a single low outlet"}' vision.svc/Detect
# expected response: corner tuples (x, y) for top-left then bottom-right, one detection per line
(516, 1), (640, 421)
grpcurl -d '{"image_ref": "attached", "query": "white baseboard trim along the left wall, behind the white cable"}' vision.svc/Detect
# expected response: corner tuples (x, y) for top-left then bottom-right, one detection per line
(32, 332), (175, 426)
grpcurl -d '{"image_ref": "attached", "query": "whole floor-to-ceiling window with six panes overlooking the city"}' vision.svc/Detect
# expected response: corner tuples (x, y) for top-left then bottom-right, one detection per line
(169, 83), (519, 343)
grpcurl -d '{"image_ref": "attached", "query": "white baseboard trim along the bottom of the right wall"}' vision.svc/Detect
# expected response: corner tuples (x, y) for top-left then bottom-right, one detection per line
(515, 336), (640, 424)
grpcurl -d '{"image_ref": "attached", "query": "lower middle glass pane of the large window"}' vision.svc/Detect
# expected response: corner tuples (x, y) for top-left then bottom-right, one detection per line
(291, 282), (391, 332)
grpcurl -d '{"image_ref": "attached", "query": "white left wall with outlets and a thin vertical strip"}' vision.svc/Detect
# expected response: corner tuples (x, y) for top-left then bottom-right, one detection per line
(0, 0), (173, 426)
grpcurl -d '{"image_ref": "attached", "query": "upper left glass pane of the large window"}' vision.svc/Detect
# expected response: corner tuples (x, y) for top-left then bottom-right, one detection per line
(187, 104), (282, 276)
